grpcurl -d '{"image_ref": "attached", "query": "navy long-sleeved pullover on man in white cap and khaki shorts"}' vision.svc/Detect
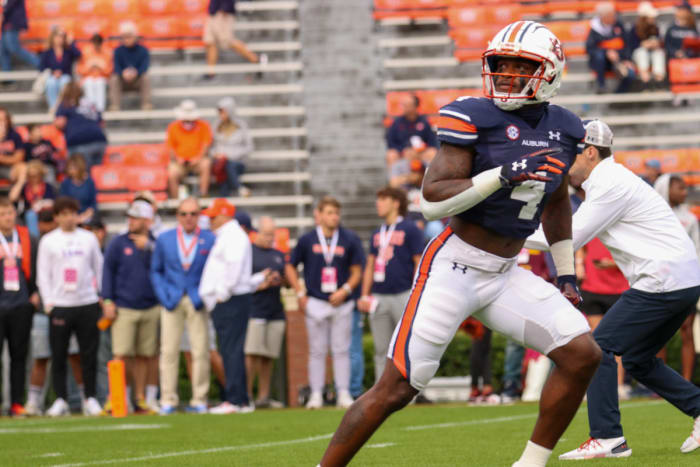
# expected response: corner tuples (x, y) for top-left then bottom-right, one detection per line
(102, 233), (158, 310)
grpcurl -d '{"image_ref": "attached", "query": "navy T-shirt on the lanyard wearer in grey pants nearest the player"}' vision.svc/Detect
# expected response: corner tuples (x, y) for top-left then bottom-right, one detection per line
(369, 219), (425, 294)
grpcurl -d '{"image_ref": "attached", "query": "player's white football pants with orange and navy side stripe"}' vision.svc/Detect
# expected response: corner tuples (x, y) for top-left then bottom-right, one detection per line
(388, 227), (590, 390)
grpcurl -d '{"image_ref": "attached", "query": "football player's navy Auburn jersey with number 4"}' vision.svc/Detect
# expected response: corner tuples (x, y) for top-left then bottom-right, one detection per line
(438, 97), (585, 238)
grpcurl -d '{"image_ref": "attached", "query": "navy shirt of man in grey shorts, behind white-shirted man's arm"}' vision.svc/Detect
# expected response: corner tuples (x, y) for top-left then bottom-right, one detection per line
(250, 245), (286, 320)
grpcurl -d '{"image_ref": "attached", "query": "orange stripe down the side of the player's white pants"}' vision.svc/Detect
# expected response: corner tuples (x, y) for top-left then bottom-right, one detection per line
(393, 226), (452, 379)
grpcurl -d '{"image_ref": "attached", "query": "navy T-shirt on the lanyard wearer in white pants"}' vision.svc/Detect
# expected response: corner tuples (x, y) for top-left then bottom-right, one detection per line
(290, 227), (365, 301)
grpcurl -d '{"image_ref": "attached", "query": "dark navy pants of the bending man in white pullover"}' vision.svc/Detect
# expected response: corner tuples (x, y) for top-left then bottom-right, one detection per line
(588, 286), (700, 438)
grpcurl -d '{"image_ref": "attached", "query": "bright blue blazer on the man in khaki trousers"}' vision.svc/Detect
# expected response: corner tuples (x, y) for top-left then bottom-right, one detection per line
(151, 229), (216, 311)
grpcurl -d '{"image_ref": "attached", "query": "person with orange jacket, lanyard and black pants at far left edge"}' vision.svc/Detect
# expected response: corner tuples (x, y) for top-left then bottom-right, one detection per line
(0, 197), (39, 416)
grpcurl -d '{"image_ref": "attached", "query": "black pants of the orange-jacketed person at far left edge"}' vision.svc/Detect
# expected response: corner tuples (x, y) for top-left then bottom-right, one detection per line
(0, 303), (34, 404)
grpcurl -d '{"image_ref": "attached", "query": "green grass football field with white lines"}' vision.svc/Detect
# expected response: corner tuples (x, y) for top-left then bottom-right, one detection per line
(0, 401), (700, 467)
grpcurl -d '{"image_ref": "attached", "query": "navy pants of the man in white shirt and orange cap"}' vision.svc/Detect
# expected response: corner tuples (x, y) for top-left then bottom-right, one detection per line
(211, 294), (251, 405)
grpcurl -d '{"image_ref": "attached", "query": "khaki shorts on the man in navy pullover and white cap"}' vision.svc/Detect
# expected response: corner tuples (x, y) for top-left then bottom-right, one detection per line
(112, 306), (160, 357)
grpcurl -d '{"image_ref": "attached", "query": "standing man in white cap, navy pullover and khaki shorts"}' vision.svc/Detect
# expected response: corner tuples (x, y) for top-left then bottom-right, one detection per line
(102, 201), (160, 413)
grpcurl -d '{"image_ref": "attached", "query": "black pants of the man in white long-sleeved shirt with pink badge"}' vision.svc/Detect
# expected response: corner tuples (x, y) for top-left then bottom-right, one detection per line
(49, 303), (102, 400)
